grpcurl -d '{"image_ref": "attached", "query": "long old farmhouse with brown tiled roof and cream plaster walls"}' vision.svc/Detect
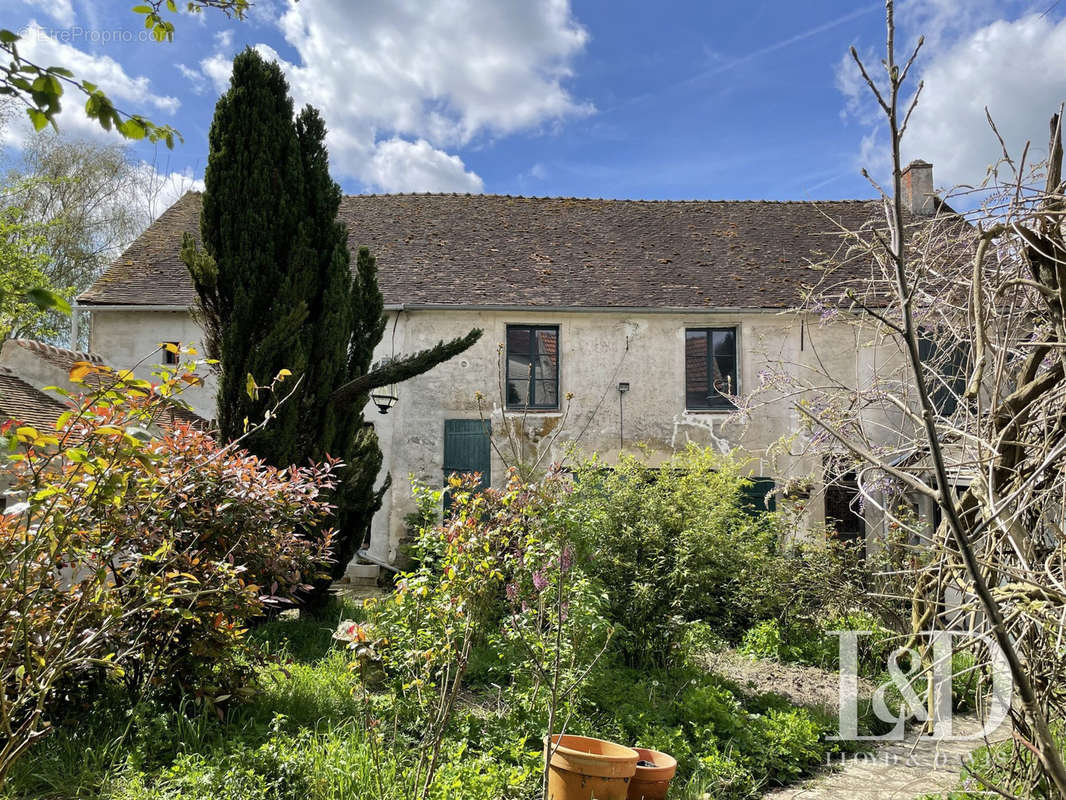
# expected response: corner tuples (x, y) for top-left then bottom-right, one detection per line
(66, 162), (934, 569)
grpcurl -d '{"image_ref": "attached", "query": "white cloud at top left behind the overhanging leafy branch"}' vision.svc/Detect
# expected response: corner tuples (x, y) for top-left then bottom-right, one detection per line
(2, 20), (180, 146)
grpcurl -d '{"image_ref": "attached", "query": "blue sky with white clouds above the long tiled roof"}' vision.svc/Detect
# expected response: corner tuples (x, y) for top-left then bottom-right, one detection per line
(6, 0), (1066, 199)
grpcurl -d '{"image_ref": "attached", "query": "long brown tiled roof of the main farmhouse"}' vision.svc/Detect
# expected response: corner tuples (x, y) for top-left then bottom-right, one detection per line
(79, 192), (899, 308)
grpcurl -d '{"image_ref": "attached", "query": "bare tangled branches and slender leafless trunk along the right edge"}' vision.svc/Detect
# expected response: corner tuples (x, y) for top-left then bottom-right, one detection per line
(741, 0), (1066, 798)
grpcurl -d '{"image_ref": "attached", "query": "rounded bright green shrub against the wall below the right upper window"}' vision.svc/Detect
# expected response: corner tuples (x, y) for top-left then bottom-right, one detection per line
(570, 446), (778, 667)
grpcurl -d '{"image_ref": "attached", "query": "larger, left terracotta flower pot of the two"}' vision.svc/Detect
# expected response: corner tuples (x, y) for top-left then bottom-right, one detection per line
(545, 734), (640, 800)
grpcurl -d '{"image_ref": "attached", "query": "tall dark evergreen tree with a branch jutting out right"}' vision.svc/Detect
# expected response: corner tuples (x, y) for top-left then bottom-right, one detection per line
(182, 49), (481, 606)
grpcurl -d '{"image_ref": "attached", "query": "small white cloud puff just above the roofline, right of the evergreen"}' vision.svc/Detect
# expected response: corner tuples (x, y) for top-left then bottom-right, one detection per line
(364, 139), (485, 193)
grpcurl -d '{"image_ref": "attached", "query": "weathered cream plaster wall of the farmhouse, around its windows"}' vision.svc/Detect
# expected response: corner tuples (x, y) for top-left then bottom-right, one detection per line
(91, 302), (893, 561)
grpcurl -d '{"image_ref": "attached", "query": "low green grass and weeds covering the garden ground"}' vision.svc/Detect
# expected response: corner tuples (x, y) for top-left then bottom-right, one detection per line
(0, 604), (857, 800)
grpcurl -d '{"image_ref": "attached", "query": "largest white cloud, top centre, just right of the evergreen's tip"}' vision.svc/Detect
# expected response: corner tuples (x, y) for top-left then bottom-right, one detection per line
(266, 0), (592, 192)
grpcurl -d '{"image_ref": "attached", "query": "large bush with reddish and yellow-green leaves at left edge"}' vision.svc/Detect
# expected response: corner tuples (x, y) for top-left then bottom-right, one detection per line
(0, 364), (335, 780)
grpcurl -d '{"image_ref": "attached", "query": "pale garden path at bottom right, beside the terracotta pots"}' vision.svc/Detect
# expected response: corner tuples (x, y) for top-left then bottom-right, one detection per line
(763, 715), (1011, 800)
